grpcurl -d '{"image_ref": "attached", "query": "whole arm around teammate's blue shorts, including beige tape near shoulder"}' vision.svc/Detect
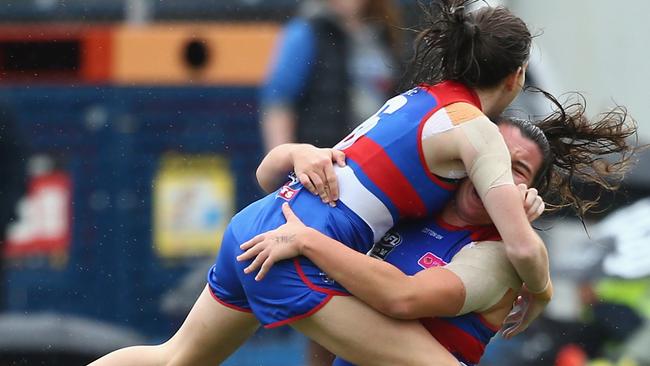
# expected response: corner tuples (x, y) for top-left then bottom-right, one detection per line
(238, 199), (540, 319)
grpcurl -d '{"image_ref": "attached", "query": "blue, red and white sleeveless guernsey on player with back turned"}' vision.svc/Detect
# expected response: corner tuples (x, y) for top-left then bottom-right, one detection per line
(336, 81), (480, 241)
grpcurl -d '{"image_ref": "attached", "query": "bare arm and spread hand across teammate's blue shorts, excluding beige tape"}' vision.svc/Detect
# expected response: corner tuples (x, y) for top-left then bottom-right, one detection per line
(237, 204), (465, 319)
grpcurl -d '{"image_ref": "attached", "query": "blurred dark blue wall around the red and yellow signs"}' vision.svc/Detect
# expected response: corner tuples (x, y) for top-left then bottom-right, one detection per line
(0, 86), (261, 339)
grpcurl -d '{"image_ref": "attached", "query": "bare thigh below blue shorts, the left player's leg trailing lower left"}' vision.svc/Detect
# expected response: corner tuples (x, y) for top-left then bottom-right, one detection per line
(164, 286), (259, 366)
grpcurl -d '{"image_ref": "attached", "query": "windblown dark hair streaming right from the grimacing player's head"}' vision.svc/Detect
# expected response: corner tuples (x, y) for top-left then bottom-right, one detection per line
(497, 89), (638, 219)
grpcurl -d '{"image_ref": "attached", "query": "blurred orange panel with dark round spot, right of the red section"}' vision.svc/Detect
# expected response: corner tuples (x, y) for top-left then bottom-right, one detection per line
(112, 23), (279, 85)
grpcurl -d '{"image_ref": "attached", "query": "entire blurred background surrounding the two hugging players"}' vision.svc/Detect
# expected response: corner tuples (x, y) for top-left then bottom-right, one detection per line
(0, 0), (650, 366)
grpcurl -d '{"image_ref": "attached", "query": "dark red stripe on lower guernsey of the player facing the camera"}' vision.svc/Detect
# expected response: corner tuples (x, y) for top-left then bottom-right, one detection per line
(420, 318), (485, 363)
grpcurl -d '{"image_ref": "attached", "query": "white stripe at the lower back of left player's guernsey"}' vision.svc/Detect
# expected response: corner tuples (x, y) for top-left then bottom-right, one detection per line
(334, 166), (394, 243)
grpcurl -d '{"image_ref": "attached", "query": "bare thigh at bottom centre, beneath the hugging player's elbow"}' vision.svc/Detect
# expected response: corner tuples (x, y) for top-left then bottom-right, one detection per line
(292, 296), (458, 366)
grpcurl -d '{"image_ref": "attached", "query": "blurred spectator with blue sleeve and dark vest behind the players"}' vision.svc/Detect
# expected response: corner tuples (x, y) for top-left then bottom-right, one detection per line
(261, 0), (401, 150)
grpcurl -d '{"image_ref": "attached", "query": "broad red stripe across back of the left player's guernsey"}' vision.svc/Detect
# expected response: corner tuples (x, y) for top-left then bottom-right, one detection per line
(345, 136), (427, 217)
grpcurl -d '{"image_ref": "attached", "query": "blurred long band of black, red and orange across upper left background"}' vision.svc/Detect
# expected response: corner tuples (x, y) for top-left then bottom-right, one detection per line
(0, 23), (280, 86)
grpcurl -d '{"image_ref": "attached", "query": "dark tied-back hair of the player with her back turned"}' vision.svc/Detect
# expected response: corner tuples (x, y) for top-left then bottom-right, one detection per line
(402, 0), (532, 88)
